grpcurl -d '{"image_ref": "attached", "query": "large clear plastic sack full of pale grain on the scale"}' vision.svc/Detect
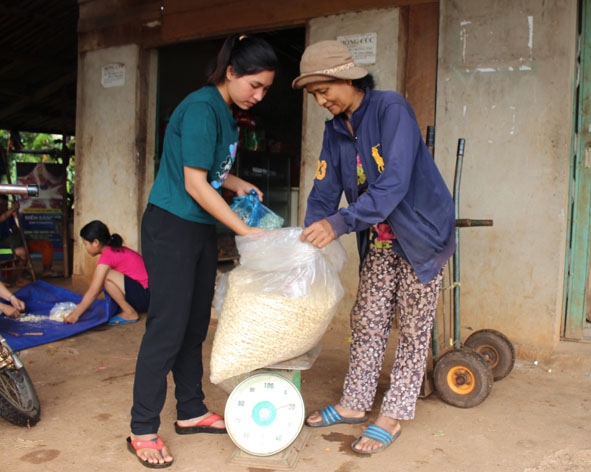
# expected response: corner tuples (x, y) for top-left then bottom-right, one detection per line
(210, 228), (346, 384)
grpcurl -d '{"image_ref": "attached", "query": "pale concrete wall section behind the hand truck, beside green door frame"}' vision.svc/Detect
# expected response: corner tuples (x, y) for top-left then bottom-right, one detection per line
(435, 0), (577, 351)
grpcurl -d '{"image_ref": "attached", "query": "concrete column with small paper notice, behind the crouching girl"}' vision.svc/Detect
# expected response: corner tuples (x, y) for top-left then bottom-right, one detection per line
(73, 45), (157, 277)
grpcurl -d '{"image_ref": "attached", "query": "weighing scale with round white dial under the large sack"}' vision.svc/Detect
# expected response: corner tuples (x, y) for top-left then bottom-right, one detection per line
(224, 346), (320, 469)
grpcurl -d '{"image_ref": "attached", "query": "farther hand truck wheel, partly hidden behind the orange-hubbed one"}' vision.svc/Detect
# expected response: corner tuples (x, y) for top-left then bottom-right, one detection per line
(464, 329), (515, 381)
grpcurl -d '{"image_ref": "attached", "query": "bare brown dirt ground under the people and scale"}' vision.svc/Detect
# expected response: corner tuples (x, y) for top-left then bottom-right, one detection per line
(0, 280), (591, 472)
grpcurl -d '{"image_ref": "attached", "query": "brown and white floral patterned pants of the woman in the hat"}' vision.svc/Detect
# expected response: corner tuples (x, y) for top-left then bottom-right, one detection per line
(339, 247), (443, 420)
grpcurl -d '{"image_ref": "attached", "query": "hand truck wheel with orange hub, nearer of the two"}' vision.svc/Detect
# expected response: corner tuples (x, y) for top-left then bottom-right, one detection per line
(433, 348), (494, 408)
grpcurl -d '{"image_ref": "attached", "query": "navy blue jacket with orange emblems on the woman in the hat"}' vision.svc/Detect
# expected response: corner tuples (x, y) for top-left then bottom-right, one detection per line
(305, 89), (456, 284)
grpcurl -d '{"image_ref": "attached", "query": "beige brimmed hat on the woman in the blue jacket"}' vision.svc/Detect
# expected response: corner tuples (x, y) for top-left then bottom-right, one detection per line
(291, 40), (369, 89)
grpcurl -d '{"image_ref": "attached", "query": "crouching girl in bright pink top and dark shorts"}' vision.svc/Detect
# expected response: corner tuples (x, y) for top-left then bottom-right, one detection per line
(64, 220), (150, 325)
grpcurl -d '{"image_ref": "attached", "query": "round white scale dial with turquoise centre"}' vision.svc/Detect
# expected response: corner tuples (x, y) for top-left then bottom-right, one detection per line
(224, 373), (305, 456)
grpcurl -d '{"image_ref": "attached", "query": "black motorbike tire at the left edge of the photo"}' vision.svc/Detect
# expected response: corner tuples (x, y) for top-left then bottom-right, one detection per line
(0, 362), (41, 427)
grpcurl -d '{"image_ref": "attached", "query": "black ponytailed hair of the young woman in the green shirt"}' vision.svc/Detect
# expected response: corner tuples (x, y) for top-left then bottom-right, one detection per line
(207, 34), (279, 85)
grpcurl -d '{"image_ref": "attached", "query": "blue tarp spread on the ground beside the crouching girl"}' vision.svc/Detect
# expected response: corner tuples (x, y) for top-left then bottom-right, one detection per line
(0, 280), (119, 351)
